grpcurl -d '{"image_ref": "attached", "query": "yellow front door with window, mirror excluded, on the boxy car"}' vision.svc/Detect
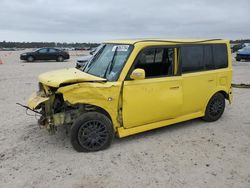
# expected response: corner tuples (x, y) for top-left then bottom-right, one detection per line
(122, 47), (183, 128)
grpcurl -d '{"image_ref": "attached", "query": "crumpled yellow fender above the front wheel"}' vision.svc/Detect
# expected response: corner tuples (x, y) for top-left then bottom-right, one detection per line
(57, 82), (121, 129)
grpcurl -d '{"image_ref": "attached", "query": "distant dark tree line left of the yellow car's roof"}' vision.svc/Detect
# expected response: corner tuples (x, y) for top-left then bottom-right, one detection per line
(0, 41), (99, 48)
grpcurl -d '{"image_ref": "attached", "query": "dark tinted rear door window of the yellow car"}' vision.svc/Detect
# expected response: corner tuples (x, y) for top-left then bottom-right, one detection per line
(181, 45), (204, 73)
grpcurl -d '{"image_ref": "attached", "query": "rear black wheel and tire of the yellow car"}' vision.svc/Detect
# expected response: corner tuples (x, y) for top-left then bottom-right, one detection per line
(203, 93), (225, 122)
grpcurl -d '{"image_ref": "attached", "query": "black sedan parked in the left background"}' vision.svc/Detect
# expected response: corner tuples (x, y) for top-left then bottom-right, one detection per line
(20, 48), (70, 62)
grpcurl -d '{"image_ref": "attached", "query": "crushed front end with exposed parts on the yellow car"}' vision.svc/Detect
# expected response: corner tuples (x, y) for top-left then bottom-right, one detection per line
(28, 83), (86, 133)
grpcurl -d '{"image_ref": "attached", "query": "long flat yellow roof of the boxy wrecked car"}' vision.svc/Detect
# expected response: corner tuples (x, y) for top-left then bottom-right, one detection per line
(105, 38), (228, 44)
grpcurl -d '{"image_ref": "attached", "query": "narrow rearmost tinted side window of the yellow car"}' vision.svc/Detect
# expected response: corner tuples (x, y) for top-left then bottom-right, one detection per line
(213, 44), (228, 69)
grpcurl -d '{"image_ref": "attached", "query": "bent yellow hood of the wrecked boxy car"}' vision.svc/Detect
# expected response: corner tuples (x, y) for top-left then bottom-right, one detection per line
(39, 68), (106, 87)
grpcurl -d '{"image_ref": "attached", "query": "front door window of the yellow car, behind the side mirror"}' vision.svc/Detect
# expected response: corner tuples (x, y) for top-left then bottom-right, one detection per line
(134, 48), (174, 78)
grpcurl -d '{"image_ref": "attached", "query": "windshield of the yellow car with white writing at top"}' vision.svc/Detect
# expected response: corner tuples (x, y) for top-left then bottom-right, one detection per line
(84, 44), (132, 81)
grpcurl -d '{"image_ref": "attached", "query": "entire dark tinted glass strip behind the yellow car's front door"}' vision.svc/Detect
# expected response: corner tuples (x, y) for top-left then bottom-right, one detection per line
(181, 44), (228, 73)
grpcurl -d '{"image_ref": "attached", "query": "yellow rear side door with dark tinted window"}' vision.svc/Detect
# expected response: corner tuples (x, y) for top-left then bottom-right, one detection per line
(181, 44), (217, 115)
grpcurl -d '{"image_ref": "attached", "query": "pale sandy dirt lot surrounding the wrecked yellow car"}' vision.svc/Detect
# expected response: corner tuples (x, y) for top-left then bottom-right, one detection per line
(0, 52), (250, 188)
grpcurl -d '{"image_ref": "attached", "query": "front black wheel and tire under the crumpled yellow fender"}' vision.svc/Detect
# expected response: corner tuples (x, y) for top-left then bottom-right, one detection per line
(70, 112), (114, 152)
